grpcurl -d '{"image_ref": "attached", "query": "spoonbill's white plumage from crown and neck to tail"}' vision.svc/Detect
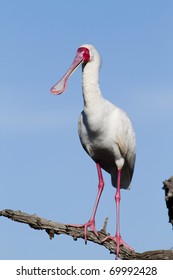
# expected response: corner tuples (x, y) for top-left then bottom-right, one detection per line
(78, 45), (136, 188)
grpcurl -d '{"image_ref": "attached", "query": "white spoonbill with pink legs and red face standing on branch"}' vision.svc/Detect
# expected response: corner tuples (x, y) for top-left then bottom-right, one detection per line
(51, 44), (136, 259)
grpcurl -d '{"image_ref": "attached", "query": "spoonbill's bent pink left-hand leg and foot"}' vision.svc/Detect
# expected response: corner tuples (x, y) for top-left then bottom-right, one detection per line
(69, 163), (104, 243)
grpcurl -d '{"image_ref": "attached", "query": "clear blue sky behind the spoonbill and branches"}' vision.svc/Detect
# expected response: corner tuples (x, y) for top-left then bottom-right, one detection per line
(0, 0), (173, 259)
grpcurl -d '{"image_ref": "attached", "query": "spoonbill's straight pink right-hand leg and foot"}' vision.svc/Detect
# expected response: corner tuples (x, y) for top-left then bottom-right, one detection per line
(103, 169), (133, 260)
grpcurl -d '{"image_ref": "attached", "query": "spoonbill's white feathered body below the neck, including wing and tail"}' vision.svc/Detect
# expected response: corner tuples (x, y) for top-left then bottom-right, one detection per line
(78, 103), (135, 188)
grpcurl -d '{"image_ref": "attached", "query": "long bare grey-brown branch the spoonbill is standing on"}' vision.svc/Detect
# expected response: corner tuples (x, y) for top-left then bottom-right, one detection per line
(0, 209), (173, 260)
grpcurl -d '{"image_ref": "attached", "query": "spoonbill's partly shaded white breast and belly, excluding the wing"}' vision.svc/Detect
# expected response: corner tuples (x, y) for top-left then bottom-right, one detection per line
(78, 109), (121, 166)
